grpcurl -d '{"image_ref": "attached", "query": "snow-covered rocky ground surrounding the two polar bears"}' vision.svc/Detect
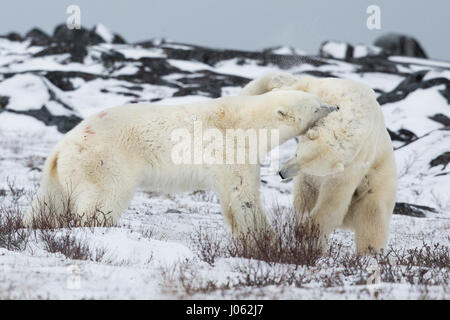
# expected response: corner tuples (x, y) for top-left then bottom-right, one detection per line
(0, 26), (450, 299)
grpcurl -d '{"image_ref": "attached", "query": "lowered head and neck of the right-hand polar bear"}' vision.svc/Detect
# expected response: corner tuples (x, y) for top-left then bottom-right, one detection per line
(280, 77), (382, 178)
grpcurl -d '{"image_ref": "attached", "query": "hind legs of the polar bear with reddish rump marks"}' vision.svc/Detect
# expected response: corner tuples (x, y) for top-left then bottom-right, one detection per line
(24, 144), (138, 228)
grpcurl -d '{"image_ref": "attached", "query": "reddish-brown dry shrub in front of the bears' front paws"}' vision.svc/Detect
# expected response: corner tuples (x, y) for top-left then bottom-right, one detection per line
(191, 206), (322, 266)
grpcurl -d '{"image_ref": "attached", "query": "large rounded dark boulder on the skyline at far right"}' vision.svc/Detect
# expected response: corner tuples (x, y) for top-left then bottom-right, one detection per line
(374, 33), (427, 58)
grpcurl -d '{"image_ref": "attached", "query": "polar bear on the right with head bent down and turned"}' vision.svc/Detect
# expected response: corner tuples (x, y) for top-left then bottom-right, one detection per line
(241, 72), (397, 253)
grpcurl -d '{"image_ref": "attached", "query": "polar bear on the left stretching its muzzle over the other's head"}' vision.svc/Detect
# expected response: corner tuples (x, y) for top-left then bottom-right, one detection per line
(25, 90), (337, 239)
